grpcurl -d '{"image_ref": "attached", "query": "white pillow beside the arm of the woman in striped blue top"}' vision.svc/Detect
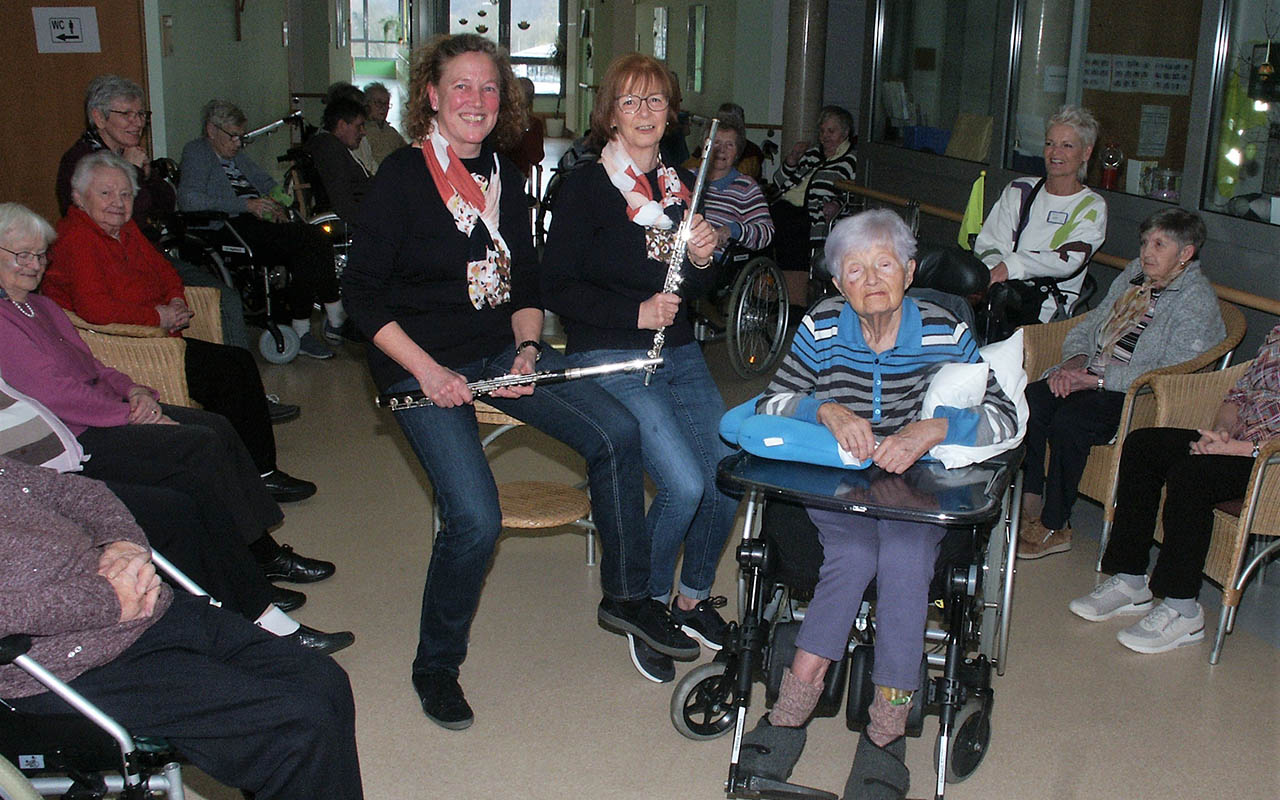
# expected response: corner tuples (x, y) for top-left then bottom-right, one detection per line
(923, 330), (1030, 468)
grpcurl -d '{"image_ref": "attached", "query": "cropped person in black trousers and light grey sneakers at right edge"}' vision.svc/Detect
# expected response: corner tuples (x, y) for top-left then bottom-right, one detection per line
(1070, 325), (1280, 653)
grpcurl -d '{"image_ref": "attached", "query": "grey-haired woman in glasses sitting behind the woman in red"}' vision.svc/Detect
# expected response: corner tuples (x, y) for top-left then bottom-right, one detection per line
(55, 74), (175, 221)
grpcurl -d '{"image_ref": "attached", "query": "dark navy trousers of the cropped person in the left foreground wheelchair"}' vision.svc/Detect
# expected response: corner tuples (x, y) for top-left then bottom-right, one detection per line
(10, 593), (364, 800)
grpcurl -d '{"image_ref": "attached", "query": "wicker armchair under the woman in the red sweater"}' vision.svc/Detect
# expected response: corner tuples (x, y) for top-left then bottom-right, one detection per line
(59, 287), (223, 407)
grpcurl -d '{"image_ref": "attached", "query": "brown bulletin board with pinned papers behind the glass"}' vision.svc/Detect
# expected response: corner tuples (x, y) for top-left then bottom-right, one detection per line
(1082, 0), (1201, 186)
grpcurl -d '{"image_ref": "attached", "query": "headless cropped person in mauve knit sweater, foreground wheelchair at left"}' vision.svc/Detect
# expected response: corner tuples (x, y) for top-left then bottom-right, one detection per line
(0, 458), (362, 800)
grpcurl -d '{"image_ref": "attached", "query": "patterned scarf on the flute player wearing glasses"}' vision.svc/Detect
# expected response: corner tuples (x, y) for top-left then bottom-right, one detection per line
(600, 140), (692, 261)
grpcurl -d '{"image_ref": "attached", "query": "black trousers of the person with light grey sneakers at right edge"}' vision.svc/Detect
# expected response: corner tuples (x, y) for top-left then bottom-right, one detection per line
(1102, 428), (1253, 598)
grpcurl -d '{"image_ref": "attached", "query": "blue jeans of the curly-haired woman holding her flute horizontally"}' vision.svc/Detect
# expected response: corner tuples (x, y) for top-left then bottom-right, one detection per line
(388, 346), (650, 675)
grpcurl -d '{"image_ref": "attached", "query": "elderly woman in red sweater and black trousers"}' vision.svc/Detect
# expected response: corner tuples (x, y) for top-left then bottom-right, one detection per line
(41, 150), (316, 502)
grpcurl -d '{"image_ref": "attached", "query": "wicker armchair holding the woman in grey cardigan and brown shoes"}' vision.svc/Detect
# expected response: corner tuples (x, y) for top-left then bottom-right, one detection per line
(1021, 300), (1244, 570)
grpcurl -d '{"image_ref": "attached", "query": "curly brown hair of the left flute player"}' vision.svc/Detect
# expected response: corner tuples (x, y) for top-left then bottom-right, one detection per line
(404, 33), (529, 148)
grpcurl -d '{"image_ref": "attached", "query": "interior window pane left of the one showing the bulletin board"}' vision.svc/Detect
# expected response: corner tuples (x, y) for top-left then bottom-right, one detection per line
(873, 0), (998, 161)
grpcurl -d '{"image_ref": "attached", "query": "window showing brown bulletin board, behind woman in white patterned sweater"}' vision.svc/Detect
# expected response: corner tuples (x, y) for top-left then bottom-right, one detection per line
(1006, 0), (1201, 202)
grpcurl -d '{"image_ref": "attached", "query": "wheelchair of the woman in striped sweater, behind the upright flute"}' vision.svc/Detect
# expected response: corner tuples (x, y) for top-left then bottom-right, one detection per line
(692, 243), (791, 379)
